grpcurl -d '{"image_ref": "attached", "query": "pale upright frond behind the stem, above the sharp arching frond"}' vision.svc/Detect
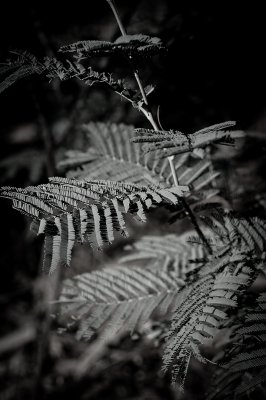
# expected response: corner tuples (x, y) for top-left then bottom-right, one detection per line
(59, 122), (219, 201)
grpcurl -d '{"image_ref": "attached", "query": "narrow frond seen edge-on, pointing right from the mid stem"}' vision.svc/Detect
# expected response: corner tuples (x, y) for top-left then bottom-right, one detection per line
(131, 121), (243, 158)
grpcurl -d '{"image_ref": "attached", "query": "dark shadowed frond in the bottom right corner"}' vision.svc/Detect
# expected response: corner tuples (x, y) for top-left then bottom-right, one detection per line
(207, 293), (266, 400)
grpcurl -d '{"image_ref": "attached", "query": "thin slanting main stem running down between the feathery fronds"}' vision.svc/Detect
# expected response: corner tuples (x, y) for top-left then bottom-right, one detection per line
(106, 0), (212, 254)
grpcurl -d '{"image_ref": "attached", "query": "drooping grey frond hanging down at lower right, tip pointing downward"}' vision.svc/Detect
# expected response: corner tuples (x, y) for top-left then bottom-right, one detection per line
(164, 254), (257, 387)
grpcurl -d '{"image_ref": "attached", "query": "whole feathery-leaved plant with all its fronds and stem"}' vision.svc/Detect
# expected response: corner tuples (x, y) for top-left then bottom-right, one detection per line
(0, 1), (266, 400)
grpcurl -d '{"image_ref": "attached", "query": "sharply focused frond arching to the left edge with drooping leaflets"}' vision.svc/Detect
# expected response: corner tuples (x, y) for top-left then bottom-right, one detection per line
(0, 177), (187, 272)
